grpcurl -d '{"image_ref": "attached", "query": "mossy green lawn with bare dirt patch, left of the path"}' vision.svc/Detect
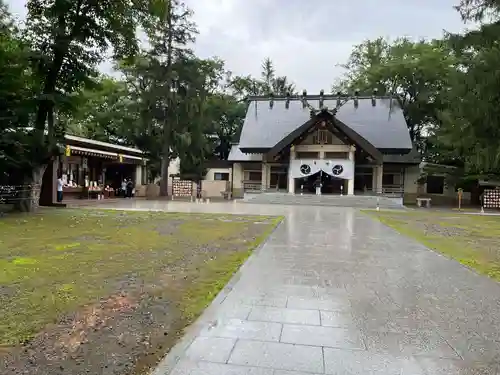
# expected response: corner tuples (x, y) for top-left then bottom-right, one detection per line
(0, 209), (281, 374)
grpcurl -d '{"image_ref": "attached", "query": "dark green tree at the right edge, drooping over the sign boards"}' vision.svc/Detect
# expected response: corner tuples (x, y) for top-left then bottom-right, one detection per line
(435, 0), (500, 177)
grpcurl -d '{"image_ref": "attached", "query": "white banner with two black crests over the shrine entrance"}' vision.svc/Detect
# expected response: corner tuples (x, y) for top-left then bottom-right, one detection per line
(290, 159), (354, 180)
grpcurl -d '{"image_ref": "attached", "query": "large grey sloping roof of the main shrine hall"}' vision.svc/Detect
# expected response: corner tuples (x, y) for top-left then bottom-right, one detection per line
(239, 98), (412, 152)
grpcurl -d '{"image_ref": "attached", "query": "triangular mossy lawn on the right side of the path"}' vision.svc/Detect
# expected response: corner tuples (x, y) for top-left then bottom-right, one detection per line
(365, 210), (500, 281)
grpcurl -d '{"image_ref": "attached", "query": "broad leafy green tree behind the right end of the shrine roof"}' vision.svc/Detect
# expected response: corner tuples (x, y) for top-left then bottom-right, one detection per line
(341, 38), (456, 153)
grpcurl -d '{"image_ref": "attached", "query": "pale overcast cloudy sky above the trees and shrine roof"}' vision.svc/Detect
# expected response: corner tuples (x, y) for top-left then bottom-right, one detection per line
(6, 0), (465, 93)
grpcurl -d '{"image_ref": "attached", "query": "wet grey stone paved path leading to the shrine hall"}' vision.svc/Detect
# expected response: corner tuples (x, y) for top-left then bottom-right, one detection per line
(96, 201), (500, 375)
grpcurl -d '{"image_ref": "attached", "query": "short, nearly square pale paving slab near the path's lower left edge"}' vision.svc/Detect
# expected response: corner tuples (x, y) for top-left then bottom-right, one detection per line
(186, 337), (236, 363)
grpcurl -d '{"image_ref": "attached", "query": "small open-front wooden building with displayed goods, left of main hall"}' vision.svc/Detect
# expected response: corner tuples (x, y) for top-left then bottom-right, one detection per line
(40, 135), (147, 206)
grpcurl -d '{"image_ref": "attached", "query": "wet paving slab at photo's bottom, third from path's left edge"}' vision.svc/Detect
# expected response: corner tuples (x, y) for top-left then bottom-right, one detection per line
(324, 348), (424, 375)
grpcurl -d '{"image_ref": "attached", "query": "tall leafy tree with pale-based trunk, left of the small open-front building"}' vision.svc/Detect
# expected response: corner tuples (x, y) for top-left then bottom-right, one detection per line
(10, 0), (149, 209)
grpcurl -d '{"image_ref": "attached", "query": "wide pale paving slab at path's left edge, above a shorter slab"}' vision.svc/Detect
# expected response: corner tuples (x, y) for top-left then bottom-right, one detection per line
(201, 319), (281, 341)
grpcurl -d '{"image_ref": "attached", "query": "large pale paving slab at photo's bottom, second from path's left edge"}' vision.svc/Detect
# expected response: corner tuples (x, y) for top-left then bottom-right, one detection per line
(229, 340), (324, 373)
